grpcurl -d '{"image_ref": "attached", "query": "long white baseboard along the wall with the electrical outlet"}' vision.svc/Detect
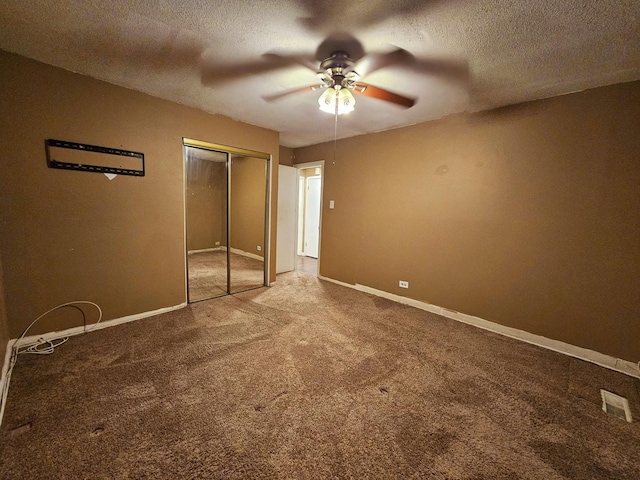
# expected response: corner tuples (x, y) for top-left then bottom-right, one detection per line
(318, 276), (640, 378)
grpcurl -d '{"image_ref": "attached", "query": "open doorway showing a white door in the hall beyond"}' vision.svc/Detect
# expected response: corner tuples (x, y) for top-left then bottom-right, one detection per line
(296, 162), (324, 275)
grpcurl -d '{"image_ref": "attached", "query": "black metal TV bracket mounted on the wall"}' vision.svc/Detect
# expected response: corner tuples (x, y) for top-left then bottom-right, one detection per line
(45, 139), (144, 177)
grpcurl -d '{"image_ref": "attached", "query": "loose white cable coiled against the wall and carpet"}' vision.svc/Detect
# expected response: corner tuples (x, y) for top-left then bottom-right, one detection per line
(0, 300), (102, 425)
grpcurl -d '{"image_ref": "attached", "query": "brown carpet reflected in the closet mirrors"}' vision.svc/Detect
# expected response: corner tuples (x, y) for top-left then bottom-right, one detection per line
(188, 250), (264, 302)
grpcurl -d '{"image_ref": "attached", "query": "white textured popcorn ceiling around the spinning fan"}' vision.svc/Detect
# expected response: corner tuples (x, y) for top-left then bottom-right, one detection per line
(0, 0), (640, 147)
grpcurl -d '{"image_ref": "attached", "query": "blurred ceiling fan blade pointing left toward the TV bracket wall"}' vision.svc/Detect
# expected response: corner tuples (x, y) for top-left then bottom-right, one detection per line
(201, 53), (318, 85)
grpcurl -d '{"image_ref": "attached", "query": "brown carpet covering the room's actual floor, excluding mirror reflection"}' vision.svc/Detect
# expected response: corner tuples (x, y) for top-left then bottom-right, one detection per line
(0, 273), (640, 480)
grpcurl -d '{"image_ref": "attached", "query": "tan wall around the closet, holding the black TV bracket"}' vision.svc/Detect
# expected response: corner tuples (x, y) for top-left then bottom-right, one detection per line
(0, 52), (279, 337)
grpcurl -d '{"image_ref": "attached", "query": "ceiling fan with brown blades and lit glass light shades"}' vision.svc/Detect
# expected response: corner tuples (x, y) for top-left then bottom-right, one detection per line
(202, 34), (469, 115)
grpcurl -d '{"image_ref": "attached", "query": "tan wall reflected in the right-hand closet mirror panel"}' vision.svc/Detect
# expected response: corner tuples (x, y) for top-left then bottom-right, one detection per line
(230, 157), (267, 257)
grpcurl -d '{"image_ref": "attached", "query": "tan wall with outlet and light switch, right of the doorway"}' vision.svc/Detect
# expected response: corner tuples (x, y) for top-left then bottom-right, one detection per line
(295, 82), (640, 362)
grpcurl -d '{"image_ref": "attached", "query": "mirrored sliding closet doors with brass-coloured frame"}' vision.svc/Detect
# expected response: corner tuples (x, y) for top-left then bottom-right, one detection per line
(184, 139), (270, 302)
